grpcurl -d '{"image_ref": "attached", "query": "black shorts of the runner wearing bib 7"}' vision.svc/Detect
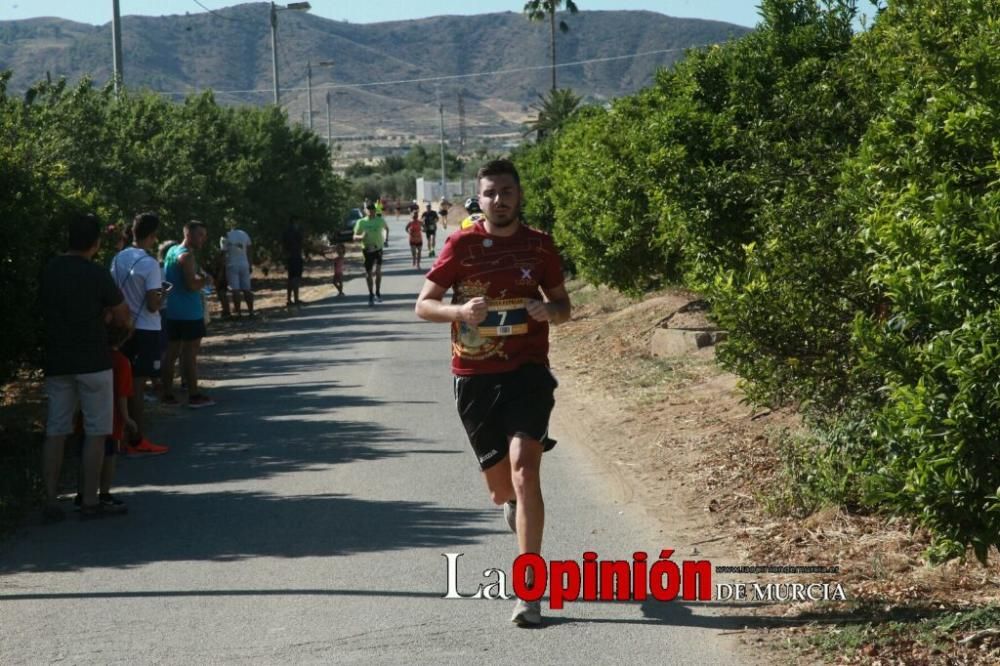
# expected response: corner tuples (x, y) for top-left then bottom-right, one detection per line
(455, 364), (559, 470)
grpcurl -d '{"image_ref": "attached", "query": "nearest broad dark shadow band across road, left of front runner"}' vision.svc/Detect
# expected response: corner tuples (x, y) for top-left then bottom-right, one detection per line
(0, 491), (496, 572)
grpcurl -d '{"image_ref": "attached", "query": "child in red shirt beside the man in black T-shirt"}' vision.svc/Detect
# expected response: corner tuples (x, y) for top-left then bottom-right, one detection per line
(75, 328), (139, 520)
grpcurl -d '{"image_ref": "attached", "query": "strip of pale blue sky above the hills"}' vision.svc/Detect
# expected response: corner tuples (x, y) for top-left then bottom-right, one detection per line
(0, 0), (772, 27)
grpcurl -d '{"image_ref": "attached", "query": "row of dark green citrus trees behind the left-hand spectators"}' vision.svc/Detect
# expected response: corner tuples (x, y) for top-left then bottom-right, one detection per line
(0, 75), (347, 381)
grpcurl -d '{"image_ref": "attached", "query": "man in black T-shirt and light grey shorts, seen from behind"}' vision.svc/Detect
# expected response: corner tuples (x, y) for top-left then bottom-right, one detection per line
(40, 210), (129, 522)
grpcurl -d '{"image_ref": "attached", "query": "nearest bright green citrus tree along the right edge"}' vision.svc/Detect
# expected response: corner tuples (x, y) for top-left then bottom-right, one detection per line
(847, 0), (1000, 559)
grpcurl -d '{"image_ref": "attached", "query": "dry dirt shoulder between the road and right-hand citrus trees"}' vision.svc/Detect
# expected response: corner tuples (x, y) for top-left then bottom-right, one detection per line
(551, 284), (1000, 664)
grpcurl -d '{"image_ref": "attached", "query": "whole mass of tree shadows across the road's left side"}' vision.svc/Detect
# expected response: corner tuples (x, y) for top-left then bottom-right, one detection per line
(0, 278), (488, 572)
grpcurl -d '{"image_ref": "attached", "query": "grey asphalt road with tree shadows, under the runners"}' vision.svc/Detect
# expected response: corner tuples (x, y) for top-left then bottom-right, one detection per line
(0, 223), (747, 665)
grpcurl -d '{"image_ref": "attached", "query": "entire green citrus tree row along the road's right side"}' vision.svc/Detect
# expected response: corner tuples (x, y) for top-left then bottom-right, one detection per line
(515, 0), (1000, 559)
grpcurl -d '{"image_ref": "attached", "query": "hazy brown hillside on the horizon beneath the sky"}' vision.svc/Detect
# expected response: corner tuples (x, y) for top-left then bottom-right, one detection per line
(0, 3), (747, 143)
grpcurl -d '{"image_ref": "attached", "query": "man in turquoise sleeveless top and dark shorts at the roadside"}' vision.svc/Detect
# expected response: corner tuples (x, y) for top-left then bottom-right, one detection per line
(163, 220), (215, 409)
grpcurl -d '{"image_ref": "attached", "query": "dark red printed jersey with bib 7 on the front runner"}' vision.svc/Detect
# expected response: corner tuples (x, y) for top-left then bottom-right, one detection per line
(427, 222), (563, 376)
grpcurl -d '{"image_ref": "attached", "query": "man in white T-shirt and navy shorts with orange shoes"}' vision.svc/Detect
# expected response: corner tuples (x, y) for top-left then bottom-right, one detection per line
(111, 213), (168, 456)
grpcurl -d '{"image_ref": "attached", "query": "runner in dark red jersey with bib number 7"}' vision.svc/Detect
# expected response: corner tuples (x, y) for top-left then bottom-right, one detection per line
(416, 160), (570, 626)
